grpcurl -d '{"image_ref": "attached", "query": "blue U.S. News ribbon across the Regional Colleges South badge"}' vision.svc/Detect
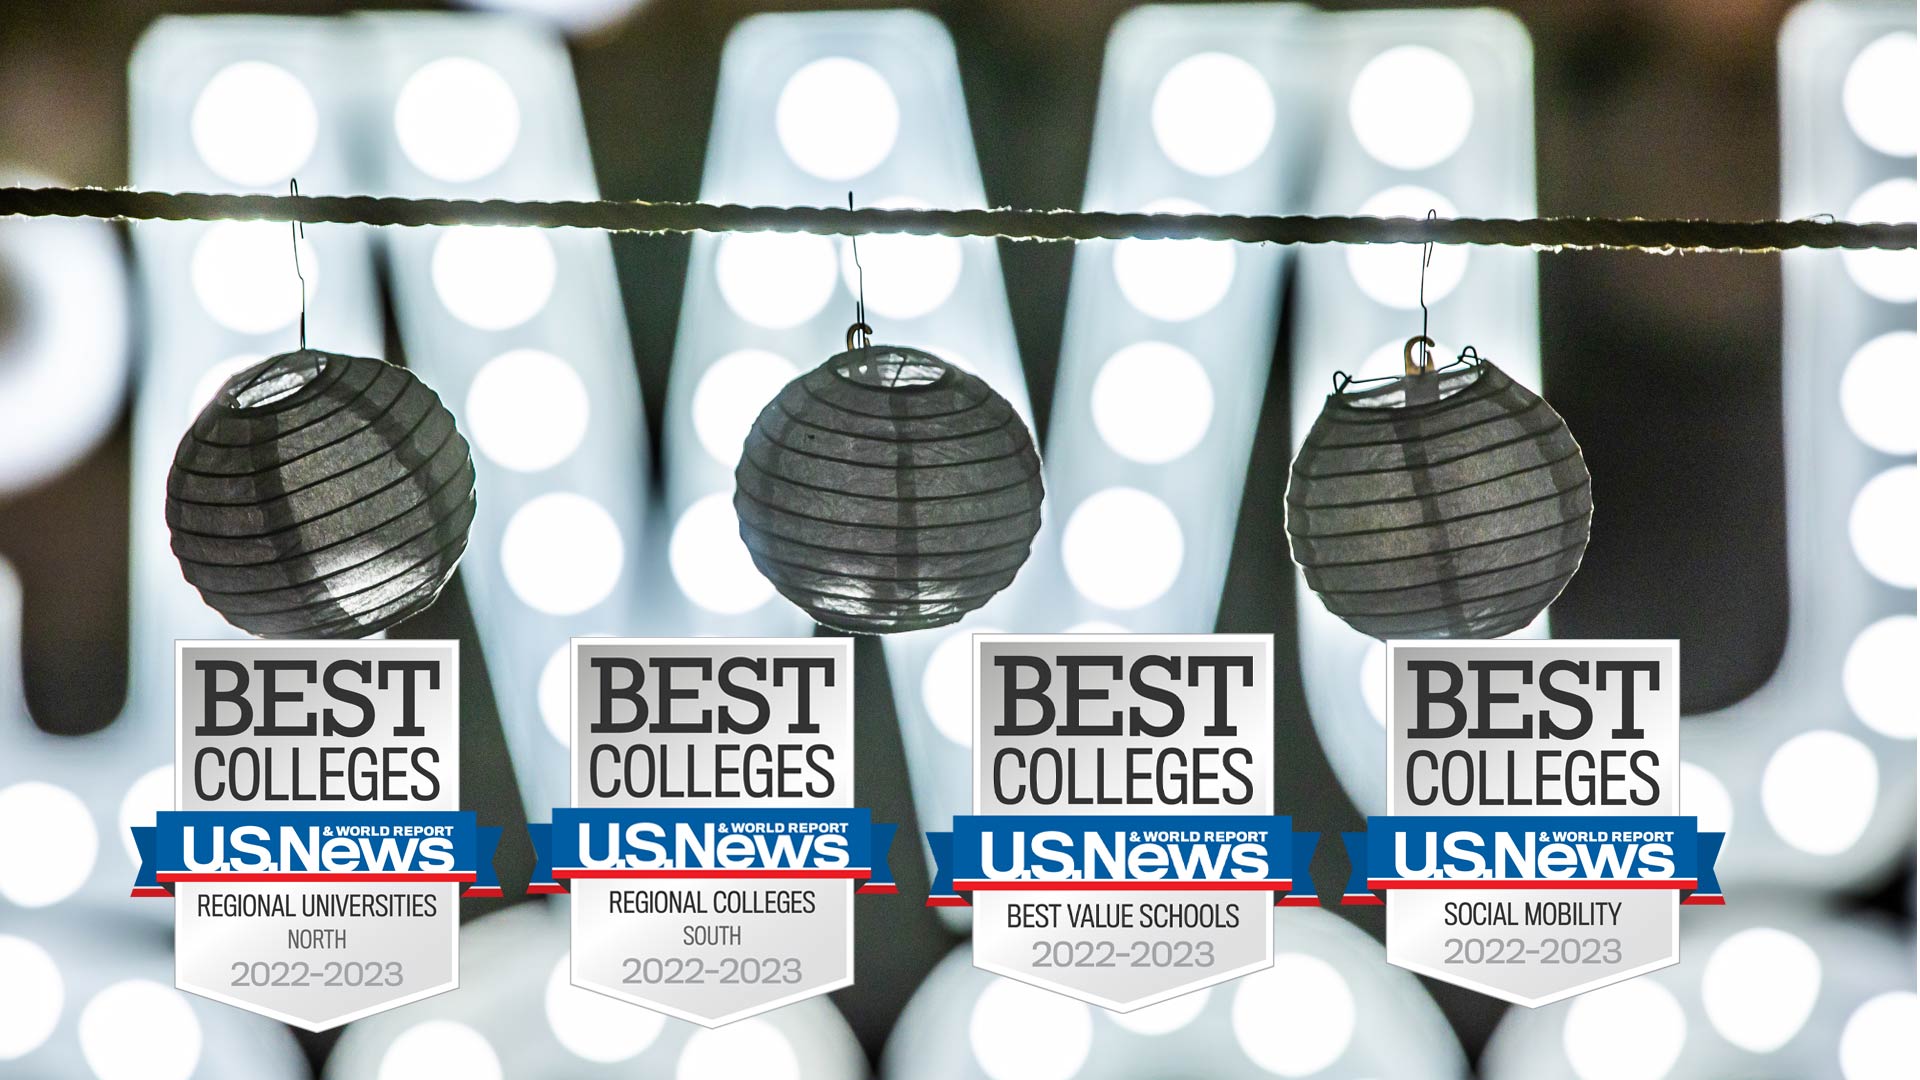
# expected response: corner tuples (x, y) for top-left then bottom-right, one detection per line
(526, 807), (899, 894)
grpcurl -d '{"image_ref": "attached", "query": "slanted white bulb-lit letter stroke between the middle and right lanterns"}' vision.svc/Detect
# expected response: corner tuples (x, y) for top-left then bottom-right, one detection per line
(868, 4), (1317, 910)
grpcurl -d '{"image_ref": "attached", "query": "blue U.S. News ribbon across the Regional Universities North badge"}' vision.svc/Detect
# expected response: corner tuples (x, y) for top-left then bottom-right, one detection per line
(132, 811), (501, 897)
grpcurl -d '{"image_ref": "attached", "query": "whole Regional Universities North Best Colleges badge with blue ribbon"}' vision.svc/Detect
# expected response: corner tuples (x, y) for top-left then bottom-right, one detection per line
(132, 642), (499, 1032)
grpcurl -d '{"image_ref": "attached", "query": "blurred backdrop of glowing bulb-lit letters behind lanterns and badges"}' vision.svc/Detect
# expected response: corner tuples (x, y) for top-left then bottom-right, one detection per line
(0, 0), (1920, 1080)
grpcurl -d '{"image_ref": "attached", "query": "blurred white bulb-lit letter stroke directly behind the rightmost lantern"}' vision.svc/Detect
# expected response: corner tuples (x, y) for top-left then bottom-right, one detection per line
(1271, 10), (1544, 813)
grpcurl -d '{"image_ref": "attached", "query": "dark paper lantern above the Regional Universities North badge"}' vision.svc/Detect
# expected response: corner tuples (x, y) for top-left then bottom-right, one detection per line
(167, 350), (474, 638)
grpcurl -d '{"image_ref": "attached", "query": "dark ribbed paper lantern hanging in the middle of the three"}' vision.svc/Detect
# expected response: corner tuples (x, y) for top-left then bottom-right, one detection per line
(733, 346), (1041, 634)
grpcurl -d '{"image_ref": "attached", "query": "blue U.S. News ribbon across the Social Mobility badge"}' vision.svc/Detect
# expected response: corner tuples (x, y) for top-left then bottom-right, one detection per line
(1340, 817), (1726, 905)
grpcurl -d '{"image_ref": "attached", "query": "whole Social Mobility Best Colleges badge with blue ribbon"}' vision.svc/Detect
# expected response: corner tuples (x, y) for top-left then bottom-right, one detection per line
(1344, 640), (1724, 1005)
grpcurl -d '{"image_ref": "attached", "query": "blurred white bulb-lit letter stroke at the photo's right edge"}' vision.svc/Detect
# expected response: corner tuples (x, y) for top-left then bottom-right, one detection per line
(1651, 2), (1920, 890)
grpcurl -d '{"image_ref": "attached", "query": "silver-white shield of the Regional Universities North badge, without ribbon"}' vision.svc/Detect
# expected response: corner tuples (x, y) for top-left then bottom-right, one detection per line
(173, 642), (465, 1032)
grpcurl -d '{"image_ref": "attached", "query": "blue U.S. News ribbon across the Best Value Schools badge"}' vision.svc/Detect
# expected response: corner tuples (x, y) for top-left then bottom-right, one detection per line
(927, 815), (1319, 907)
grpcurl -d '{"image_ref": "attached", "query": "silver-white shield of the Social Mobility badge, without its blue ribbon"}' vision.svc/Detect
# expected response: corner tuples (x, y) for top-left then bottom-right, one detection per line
(1386, 640), (1680, 999)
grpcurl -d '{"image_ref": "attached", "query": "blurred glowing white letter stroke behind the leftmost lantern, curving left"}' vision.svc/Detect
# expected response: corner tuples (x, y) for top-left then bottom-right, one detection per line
(0, 17), (380, 920)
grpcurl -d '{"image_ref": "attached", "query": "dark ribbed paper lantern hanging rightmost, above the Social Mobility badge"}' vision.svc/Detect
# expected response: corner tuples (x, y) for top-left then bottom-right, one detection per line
(1286, 361), (1594, 638)
